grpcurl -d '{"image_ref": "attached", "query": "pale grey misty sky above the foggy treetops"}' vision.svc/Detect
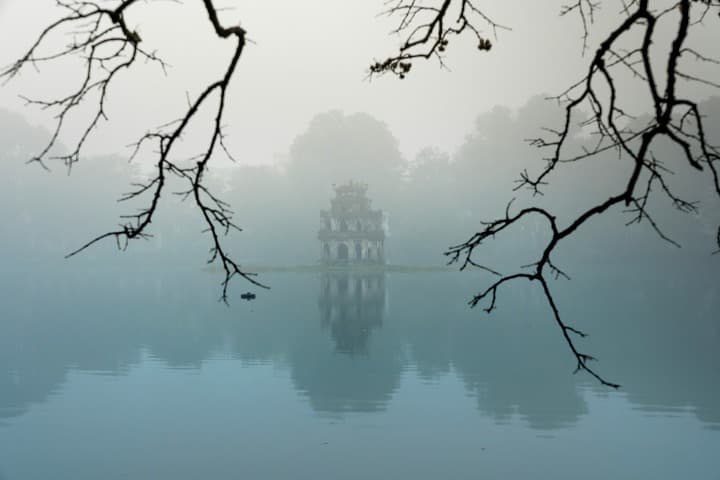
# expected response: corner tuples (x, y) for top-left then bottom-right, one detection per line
(0, 0), (720, 164)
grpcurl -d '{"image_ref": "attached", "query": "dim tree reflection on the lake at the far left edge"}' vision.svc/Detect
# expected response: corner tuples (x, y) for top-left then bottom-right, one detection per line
(0, 275), (138, 417)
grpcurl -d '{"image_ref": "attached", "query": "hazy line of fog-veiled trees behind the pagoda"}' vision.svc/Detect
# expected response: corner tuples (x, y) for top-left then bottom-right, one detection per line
(0, 95), (720, 266)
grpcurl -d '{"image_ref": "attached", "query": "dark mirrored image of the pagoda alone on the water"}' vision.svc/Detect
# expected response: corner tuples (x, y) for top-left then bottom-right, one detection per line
(318, 271), (386, 353)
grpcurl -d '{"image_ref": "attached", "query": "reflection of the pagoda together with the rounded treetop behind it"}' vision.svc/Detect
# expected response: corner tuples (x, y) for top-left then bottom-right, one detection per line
(289, 271), (403, 413)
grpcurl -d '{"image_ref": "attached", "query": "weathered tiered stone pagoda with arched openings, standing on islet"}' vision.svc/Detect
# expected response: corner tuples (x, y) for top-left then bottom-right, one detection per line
(318, 182), (385, 264)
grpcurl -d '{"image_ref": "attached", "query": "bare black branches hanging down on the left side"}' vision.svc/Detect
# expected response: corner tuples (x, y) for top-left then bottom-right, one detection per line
(0, 0), (267, 302)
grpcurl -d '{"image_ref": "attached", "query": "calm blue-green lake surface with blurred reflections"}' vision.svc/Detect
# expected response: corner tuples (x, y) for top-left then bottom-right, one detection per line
(0, 262), (720, 480)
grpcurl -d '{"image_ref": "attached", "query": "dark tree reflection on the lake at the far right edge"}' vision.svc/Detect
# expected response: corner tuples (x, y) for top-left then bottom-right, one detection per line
(577, 264), (720, 426)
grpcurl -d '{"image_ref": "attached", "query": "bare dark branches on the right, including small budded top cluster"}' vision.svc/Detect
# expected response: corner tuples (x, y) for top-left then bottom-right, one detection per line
(370, 0), (720, 388)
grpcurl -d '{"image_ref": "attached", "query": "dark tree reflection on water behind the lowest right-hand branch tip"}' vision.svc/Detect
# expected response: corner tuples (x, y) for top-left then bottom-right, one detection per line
(392, 274), (587, 429)
